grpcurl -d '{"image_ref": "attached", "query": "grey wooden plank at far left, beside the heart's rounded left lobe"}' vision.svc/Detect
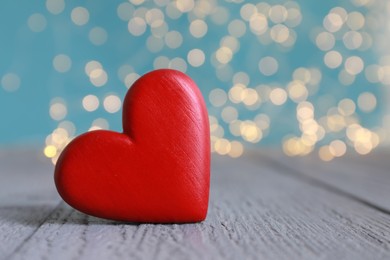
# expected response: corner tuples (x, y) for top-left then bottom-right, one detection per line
(0, 150), (60, 259)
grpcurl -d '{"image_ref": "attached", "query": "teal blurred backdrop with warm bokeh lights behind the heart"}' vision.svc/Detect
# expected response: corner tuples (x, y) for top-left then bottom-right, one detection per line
(0, 0), (390, 163)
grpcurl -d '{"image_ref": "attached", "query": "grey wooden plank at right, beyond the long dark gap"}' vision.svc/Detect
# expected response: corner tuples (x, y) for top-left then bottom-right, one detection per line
(260, 150), (390, 212)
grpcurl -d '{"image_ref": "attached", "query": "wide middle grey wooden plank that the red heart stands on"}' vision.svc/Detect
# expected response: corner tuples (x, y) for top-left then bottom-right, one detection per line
(0, 151), (390, 259)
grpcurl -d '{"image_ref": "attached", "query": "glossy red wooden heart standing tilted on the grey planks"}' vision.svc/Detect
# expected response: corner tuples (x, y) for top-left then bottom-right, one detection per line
(55, 69), (210, 223)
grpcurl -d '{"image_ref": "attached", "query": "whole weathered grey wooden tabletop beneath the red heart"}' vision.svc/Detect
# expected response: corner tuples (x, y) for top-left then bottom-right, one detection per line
(0, 150), (390, 259)
